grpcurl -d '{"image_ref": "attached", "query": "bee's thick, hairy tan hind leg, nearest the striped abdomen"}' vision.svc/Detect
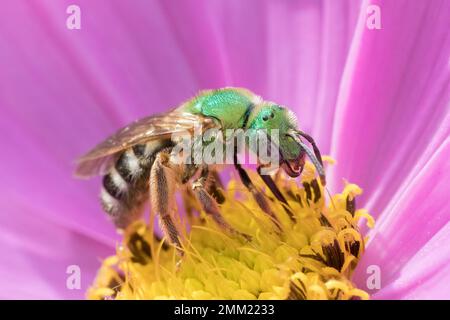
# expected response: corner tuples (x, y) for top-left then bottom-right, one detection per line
(150, 151), (183, 255)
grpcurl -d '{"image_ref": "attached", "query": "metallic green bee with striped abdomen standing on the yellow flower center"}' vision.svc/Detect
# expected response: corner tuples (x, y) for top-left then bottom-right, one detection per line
(75, 88), (325, 252)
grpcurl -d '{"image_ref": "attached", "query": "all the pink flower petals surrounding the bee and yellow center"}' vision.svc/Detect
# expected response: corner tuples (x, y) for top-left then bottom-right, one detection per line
(0, 0), (450, 299)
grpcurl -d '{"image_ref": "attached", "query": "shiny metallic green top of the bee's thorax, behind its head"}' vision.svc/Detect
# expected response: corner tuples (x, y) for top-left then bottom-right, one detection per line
(180, 88), (257, 129)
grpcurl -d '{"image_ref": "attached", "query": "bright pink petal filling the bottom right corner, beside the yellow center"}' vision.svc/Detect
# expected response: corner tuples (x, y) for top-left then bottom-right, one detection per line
(354, 138), (450, 298)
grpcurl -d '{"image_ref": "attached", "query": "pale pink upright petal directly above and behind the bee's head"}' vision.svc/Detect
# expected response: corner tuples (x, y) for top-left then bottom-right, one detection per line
(265, 1), (361, 154)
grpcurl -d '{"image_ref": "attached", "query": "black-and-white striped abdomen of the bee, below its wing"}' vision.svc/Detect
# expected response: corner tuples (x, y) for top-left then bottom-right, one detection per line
(100, 140), (171, 228)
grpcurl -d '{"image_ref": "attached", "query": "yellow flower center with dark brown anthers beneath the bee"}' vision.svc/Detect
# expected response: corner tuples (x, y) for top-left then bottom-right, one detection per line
(87, 157), (374, 299)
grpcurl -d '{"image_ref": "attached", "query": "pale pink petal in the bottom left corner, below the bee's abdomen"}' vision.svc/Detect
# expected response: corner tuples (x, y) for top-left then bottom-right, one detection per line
(0, 198), (113, 299)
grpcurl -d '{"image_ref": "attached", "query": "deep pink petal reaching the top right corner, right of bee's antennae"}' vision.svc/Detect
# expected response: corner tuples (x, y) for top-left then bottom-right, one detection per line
(330, 1), (450, 220)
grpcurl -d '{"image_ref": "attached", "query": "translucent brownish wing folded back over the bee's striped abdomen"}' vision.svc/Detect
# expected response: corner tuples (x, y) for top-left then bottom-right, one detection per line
(75, 110), (215, 178)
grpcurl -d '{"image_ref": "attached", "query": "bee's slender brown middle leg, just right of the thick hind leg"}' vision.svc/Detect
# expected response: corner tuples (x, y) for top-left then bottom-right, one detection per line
(192, 167), (251, 241)
